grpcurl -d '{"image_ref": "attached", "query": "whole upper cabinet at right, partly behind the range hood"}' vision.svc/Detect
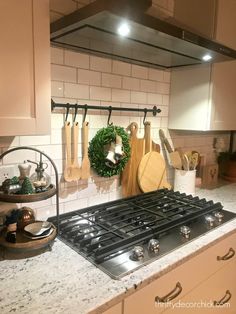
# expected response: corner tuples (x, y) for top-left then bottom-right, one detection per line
(169, 0), (236, 131)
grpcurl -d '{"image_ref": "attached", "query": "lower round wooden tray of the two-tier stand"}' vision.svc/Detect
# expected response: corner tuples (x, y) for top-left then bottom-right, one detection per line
(0, 225), (57, 253)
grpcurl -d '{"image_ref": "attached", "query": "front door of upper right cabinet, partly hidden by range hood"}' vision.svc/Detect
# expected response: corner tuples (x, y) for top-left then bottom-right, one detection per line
(211, 0), (236, 130)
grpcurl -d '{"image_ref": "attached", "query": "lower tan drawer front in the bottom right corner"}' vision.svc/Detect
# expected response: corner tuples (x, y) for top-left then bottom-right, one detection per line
(165, 261), (236, 314)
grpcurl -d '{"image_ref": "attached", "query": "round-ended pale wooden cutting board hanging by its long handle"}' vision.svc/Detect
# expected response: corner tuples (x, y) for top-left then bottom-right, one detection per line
(138, 122), (171, 192)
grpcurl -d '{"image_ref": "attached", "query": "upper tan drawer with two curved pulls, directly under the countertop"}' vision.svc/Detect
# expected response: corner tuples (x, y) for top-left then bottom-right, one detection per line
(124, 234), (236, 314)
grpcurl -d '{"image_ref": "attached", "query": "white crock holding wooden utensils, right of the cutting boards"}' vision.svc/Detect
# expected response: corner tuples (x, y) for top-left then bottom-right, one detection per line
(174, 169), (196, 194)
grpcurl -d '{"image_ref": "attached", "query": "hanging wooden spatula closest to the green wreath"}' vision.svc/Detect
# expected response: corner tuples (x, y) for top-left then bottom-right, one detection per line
(81, 121), (90, 180)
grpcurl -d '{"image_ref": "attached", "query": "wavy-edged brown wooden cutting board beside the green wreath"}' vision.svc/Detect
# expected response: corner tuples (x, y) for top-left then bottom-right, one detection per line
(121, 122), (144, 197)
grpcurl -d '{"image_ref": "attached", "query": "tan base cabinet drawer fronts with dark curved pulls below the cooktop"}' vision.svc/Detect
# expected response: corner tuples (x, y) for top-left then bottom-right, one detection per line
(124, 234), (236, 314)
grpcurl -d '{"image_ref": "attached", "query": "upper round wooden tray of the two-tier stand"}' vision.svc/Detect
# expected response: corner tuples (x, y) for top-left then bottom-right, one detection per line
(0, 184), (56, 203)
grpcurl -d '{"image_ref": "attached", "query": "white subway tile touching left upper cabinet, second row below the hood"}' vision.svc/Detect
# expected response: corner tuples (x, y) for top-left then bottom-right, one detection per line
(51, 64), (76, 83)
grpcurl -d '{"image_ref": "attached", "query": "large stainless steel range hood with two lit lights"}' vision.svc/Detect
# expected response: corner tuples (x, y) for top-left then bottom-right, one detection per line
(51, 0), (236, 69)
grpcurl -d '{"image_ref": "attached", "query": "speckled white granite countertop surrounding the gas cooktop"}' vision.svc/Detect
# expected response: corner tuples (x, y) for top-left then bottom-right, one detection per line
(0, 184), (236, 314)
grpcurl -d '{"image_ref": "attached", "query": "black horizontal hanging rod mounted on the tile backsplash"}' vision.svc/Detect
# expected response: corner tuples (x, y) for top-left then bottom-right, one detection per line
(51, 100), (161, 116)
